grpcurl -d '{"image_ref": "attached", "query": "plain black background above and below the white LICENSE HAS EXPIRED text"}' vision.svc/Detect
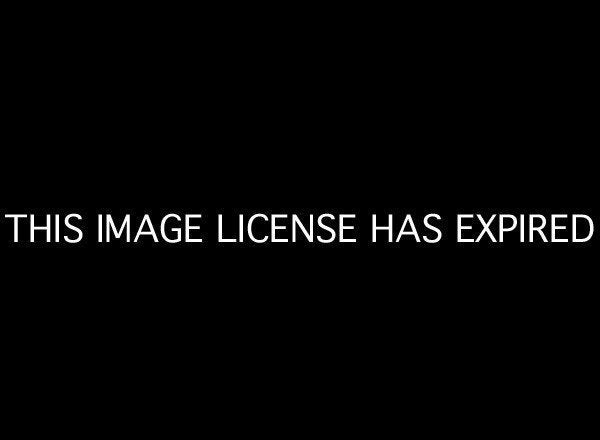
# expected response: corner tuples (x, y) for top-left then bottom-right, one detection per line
(1, 5), (598, 433)
